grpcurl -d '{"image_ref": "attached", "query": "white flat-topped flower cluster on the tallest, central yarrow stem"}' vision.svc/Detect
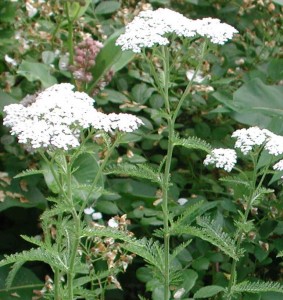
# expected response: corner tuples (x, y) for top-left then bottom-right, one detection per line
(116, 8), (238, 53)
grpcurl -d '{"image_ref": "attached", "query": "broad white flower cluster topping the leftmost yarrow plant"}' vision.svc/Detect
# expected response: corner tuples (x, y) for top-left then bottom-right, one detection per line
(3, 83), (143, 150)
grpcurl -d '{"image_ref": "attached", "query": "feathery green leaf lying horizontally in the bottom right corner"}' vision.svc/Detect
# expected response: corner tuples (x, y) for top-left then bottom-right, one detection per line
(233, 281), (283, 294)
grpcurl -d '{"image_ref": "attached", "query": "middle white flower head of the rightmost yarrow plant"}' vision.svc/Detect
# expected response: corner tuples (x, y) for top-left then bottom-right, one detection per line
(232, 126), (271, 155)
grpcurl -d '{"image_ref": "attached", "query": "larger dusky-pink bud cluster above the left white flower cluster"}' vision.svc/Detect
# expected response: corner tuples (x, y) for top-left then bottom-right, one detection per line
(69, 38), (103, 82)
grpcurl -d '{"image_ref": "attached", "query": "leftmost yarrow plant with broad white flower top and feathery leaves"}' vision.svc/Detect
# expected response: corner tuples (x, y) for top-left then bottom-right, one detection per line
(0, 83), (143, 300)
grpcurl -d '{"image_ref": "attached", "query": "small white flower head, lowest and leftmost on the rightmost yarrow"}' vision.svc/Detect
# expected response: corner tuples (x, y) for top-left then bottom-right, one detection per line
(203, 148), (237, 172)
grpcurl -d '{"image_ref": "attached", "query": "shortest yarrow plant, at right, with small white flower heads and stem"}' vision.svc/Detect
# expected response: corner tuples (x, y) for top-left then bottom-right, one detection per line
(204, 126), (283, 300)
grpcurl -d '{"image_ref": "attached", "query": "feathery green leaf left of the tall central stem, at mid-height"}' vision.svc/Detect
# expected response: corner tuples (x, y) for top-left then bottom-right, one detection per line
(104, 163), (163, 185)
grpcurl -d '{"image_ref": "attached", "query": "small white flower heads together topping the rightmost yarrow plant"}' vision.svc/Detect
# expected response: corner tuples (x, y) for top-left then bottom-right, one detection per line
(204, 126), (283, 172)
